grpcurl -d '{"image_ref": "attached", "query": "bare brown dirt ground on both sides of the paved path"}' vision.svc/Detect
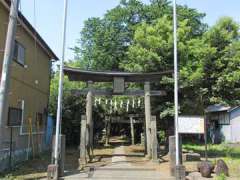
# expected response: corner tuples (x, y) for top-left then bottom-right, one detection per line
(0, 137), (239, 180)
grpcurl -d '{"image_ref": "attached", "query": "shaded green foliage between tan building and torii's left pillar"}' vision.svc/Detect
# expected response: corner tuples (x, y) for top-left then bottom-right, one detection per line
(49, 72), (85, 144)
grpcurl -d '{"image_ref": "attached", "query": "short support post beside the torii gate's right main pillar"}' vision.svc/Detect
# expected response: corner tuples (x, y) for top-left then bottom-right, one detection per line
(151, 116), (158, 162)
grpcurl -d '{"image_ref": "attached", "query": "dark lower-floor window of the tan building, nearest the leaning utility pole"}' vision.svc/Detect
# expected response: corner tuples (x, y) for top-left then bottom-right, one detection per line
(8, 107), (22, 126)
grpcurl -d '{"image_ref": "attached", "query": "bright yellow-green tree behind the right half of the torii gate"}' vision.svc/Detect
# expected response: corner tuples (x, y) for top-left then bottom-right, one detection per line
(121, 16), (207, 118)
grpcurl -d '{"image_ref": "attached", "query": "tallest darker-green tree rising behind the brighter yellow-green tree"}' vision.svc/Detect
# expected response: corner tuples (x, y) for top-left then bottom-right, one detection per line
(73, 0), (206, 70)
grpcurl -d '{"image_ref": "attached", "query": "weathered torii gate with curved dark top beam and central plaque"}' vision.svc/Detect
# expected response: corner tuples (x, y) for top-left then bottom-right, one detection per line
(63, 67), (172, 167)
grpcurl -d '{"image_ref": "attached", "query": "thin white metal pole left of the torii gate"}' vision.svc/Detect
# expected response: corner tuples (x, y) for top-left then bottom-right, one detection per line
(54, 0), (68, 169)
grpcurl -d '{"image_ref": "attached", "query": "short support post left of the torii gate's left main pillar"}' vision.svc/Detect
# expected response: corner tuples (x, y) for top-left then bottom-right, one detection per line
(79, 115), (87, 169)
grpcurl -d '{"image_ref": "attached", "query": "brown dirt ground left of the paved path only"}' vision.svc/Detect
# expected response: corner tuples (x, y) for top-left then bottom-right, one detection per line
(0, 138), (118, 180)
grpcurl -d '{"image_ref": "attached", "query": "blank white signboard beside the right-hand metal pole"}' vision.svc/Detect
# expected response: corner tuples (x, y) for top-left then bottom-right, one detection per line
(178, 116), (204, 134)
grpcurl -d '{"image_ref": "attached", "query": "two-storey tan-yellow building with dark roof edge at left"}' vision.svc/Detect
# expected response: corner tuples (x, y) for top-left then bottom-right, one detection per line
(0, 0), (58, 170)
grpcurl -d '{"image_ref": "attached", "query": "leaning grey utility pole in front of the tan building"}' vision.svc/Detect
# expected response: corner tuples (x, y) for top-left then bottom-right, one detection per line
(0, 0), (20, 126)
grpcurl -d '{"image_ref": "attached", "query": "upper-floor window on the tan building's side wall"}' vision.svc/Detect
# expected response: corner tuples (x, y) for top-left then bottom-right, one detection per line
(13, 41), (25, 65)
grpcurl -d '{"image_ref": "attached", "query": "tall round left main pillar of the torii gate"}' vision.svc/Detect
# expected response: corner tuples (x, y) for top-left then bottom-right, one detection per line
(86, 81), (93, 159)
